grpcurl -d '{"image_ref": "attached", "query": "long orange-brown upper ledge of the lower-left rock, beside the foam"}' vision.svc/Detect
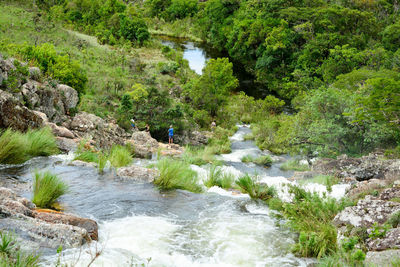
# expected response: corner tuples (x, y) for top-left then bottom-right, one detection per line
(33, 211), (98, 240)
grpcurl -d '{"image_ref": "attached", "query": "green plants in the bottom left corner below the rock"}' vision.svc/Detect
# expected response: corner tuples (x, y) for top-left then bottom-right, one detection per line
(0, 231), (39, 267)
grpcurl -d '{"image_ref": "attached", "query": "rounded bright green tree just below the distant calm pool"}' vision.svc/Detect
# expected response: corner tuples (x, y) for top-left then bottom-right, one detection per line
(185, 58), (238, 116)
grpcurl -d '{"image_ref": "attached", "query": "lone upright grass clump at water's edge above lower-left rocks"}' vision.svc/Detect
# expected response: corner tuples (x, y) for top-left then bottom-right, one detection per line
(32, 171), (68, 208)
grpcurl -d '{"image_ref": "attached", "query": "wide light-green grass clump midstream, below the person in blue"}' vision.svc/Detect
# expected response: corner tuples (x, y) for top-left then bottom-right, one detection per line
(154, 158), (203, 193)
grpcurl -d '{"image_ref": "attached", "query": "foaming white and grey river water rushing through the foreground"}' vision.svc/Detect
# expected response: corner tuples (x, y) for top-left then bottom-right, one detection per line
(3, 126), (348, 267)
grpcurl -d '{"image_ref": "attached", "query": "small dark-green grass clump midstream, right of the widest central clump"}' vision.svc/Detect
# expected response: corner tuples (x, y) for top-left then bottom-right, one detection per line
(236, 174), (276, 200)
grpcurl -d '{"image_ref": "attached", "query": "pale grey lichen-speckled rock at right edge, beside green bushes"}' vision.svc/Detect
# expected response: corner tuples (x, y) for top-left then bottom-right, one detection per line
(333, 196), (400, 227)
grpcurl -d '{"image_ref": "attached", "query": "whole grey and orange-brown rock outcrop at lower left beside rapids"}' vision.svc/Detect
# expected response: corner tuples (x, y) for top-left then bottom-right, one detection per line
(0, 187), (97, 248)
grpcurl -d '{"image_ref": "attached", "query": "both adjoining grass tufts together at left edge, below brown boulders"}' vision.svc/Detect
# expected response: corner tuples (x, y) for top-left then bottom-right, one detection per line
(0, 127), (58, 164)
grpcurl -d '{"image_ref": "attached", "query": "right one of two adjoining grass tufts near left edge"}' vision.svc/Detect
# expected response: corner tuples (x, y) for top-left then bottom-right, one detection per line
(25, 127), (59, 157)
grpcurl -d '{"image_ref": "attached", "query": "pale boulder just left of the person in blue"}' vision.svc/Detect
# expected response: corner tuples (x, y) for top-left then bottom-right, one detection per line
(126, 131), (158, 158)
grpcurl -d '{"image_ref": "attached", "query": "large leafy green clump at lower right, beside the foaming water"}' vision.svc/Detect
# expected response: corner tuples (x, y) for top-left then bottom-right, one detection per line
(269, 185), (350, 258)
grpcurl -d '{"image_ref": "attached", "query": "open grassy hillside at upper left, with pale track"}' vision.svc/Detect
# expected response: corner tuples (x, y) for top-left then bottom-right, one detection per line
(0, 3), (194, 117)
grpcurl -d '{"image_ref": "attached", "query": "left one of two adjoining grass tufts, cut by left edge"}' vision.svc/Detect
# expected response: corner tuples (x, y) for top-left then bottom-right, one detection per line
(0, 129), (29, 164)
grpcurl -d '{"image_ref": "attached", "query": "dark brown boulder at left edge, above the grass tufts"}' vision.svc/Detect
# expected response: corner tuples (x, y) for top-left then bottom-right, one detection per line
(0, 90), (44, 131)
